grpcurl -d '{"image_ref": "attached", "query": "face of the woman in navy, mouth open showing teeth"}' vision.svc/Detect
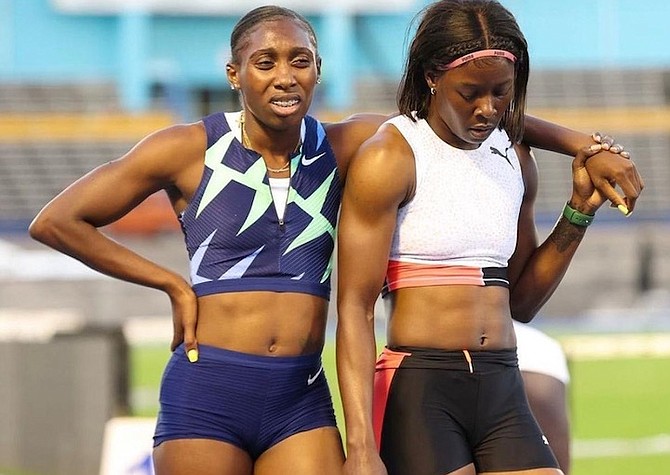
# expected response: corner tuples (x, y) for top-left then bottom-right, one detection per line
(226, 19), (320, 130)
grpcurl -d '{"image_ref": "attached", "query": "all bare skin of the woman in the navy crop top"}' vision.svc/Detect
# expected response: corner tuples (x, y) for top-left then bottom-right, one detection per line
(30, 14), (634, 475)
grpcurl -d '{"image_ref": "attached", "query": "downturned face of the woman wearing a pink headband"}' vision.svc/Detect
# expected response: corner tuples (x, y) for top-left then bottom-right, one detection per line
(426, 58), (514, 150)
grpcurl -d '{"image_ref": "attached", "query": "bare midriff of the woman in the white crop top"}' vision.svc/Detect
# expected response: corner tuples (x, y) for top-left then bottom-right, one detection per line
(387, 285), (516, 351)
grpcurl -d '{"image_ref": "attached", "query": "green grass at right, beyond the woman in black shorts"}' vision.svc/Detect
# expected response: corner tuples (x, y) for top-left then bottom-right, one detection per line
(570, 358), (670, 475)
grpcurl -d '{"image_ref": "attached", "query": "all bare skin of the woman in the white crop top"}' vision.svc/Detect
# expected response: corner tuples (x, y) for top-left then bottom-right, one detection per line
(337, 58), (616, 475)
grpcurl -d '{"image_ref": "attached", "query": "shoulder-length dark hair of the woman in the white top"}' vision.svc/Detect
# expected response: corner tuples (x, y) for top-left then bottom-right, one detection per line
(398, 0), (529, 142)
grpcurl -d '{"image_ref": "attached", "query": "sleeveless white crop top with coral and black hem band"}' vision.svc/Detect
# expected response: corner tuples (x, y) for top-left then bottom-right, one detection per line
(385, 116), (524, 291)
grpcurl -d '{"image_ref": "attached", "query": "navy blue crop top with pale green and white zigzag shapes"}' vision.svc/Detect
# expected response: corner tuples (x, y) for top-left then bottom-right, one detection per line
(179, 112), (341, 299)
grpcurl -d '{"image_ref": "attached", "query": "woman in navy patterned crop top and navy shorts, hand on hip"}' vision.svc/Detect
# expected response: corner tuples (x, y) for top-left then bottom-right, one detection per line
(30, 6), (635, 475)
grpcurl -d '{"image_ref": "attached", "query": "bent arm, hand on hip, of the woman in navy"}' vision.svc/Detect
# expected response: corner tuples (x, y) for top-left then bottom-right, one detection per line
(29, 125), (205, 356)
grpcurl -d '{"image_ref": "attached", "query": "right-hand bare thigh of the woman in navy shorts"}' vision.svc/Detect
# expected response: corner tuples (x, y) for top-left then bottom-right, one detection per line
(254, 427), (344, 475)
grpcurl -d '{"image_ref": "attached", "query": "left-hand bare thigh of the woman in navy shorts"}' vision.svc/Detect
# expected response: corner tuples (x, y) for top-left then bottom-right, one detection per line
(153, 439), (253, 475)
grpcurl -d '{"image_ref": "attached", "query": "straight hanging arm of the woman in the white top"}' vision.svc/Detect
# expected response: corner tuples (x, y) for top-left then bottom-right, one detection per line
(336, 126), (412, 475)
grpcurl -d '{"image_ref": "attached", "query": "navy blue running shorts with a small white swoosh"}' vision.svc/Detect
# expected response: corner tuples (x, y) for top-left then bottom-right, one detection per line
(154, 345), (336, 459)
